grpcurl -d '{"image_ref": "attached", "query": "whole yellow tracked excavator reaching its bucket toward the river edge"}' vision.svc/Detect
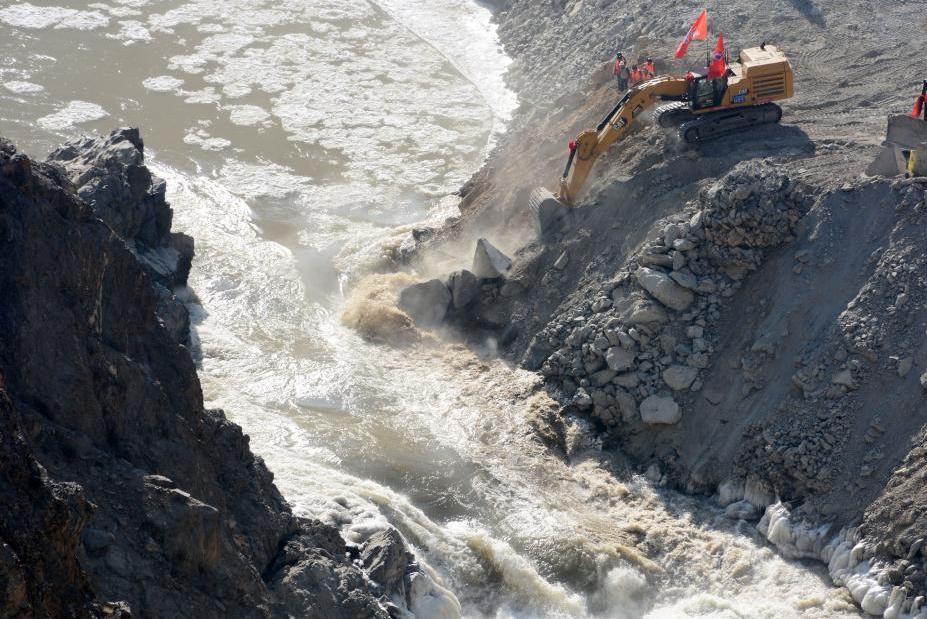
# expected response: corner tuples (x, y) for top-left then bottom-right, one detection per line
(531, 43), (793, 218)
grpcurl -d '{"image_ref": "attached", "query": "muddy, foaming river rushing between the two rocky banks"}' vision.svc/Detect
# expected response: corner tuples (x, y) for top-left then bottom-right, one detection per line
(0, 0), (856, 618)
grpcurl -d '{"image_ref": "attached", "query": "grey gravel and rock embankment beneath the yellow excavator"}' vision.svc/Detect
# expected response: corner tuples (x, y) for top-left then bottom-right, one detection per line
(410, 0), (927, 616)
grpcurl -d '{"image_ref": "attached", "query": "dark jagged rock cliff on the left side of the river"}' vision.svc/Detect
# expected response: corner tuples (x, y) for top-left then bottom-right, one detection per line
(0, 130), (398, 617)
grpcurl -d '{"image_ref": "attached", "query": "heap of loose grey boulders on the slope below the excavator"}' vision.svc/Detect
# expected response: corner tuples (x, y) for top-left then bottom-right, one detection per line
(525, 162), (810, 425)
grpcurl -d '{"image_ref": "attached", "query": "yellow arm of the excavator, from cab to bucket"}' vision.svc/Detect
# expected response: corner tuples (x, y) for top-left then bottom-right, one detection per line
(548, 77), (689, 205)
